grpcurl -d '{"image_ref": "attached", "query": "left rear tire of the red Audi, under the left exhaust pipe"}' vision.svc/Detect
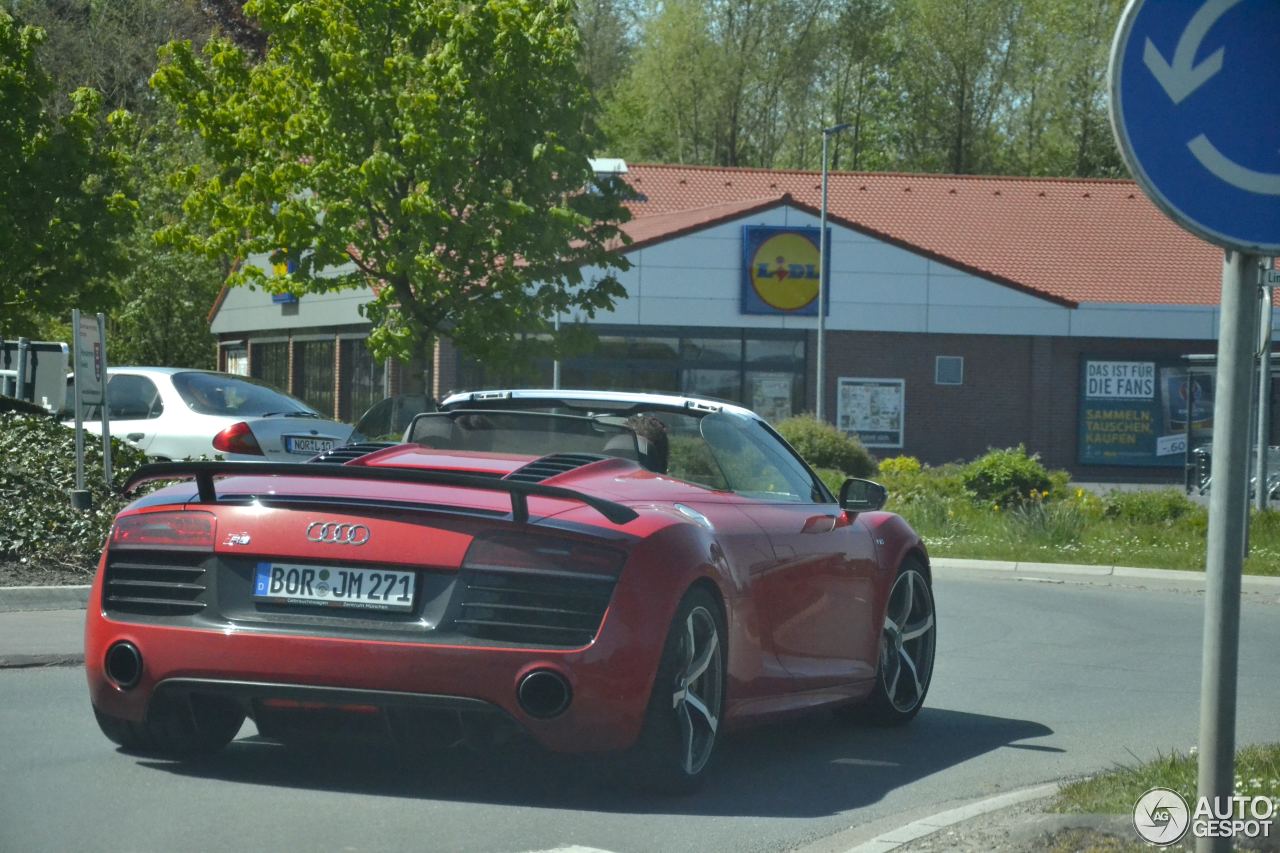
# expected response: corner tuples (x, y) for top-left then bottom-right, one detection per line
(93, 695), (244, 757)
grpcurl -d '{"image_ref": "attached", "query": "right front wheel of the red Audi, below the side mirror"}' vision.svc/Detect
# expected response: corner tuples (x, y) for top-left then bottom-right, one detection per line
(836, 557), (938, 726)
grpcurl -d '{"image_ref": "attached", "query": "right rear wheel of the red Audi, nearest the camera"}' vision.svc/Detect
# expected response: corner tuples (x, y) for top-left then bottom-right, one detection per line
(625, 588), (727, 795)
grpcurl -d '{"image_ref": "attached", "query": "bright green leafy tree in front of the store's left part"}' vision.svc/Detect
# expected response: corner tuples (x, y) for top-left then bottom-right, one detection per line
(152, 0), (626, 357)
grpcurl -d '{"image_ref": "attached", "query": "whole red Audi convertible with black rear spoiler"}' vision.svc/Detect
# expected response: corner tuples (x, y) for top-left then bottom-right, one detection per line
(84, 391), (936, 792)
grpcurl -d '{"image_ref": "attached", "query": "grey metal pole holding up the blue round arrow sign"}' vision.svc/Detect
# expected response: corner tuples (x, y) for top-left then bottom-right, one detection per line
(1196, 251), (1258, 853)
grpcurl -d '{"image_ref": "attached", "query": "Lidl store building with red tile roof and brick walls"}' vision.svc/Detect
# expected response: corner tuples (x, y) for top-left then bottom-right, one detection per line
(211, 164), (1249, 482)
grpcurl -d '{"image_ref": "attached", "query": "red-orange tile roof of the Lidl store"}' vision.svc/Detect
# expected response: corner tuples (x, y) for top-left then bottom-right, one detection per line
(625, 164), (1222, 305)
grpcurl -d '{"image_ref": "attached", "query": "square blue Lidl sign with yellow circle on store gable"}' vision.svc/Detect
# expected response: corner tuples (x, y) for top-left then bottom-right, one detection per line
(742, 225), (829, 316)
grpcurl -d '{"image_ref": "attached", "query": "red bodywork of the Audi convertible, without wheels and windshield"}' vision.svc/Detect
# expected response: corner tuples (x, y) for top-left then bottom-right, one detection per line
(84, 392), (932, 778)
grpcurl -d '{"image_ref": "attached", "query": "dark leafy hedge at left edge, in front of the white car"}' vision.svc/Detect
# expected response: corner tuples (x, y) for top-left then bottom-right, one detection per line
(0, 412), (143, 575)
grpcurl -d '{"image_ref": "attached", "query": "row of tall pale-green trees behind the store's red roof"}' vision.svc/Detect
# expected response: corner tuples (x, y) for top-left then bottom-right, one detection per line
(585, 0), (1123, 177)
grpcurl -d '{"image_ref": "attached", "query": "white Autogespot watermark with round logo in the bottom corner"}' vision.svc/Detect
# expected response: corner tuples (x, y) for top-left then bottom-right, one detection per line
(1133, 788), (1280, 847)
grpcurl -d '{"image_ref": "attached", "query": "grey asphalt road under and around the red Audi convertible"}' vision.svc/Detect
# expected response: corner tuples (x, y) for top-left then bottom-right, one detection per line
(0, 573), (1280, 853)
